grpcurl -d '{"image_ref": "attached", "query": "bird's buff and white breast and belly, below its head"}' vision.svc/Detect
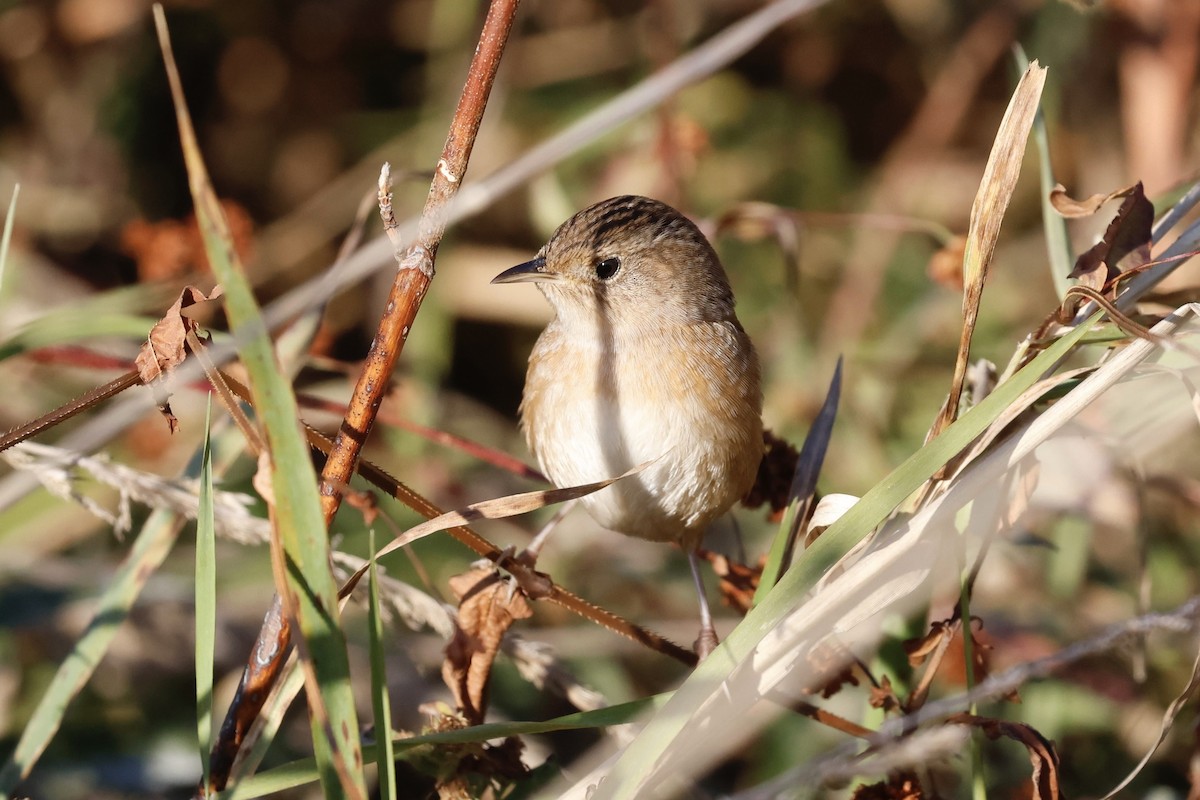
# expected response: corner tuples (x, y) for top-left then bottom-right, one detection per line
(522, 323), (762, 543)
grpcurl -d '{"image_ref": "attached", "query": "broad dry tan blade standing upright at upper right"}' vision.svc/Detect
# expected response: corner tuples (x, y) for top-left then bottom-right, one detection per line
(929, 60), (1046, 439)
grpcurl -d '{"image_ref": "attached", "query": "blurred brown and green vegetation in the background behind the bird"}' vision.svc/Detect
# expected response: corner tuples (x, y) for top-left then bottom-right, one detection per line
(0, 0), (1200, 798)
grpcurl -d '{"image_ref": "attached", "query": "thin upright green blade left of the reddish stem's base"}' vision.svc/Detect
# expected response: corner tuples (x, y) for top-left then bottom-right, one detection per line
(196, 395), (217, 787)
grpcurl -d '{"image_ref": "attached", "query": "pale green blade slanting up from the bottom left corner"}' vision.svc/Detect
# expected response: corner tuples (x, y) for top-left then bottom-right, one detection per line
(0, 511), (180, 798)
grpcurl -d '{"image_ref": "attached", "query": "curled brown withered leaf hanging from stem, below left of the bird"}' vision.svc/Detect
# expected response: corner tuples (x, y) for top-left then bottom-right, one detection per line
(442, 567), (533, 724)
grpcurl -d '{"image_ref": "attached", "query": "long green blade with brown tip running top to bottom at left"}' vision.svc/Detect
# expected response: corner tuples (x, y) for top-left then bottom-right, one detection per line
(155, 5), (366, 798)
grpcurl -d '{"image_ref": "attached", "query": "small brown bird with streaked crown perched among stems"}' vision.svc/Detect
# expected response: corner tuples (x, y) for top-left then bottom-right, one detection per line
(492, 196), (763, 656)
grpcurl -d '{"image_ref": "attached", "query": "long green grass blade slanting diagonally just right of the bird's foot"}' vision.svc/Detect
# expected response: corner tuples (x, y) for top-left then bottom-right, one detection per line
(594, 314), (1099, 800)
